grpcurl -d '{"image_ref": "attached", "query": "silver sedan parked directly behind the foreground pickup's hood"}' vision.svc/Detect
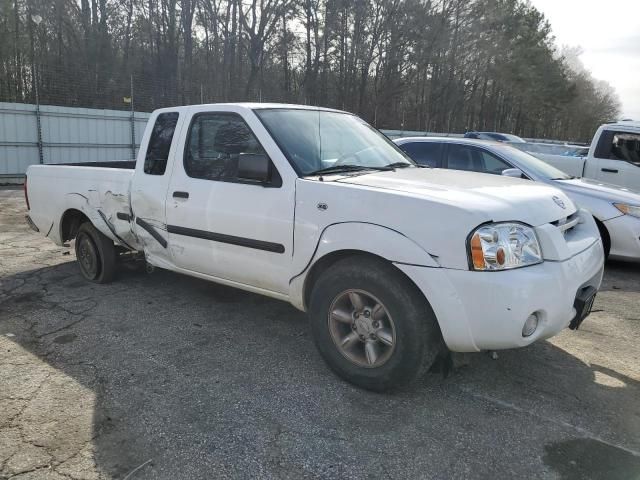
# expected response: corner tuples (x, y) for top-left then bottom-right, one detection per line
(395, 137), (640, 261)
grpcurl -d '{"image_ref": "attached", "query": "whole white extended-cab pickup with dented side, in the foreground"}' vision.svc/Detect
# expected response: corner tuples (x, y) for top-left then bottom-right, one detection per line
(25, 104), (603, 390)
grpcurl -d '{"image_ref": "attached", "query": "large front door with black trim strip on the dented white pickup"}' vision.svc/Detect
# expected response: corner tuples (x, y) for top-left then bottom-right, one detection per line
(167, 107), (295, 293)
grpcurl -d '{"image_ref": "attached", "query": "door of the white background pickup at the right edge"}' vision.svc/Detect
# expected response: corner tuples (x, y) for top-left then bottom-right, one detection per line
(588, 130), (640, 190)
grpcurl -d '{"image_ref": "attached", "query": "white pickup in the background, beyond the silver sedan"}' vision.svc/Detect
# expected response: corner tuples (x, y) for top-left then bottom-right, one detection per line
(536, 121), (640, 192)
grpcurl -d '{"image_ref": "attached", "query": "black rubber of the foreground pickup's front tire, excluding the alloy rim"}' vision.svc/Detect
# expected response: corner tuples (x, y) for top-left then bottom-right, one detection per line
(309, 257), (443, 392)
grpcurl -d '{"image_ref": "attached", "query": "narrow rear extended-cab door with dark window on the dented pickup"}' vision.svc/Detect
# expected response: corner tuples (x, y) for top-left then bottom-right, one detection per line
(131, 111), (182, 268)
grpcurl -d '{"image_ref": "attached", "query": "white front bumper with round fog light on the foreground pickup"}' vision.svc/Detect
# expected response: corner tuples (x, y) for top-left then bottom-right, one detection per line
(397, 240), (604, 352)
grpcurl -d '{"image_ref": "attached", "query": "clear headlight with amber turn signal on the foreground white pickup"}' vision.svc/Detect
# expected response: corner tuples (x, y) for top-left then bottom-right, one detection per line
(468, 222), (542, 271)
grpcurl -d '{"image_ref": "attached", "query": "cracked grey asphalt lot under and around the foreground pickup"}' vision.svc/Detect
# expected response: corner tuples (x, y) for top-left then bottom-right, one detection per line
(0, 189), (640, 479)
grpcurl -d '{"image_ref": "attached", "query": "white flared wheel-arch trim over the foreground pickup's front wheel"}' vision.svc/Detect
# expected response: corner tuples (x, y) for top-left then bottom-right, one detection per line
(289, 222), (440, 310)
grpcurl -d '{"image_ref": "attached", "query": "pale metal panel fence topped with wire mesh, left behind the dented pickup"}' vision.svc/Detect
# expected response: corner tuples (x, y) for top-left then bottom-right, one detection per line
(0, 62), (283, 178)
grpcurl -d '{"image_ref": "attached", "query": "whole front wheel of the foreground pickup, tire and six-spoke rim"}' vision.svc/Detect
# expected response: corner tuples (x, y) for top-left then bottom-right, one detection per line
(309, 257), (442, 391)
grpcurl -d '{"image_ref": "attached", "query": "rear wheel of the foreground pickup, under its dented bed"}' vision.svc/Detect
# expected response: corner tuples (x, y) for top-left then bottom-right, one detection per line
(75, 222), (116, 283)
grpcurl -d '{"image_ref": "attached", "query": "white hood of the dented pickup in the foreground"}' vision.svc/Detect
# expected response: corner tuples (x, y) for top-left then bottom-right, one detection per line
(335, 168), (576, 226)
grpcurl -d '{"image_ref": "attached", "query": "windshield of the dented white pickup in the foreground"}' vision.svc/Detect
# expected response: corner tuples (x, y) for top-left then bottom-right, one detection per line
(255, 109), (414, 175)
